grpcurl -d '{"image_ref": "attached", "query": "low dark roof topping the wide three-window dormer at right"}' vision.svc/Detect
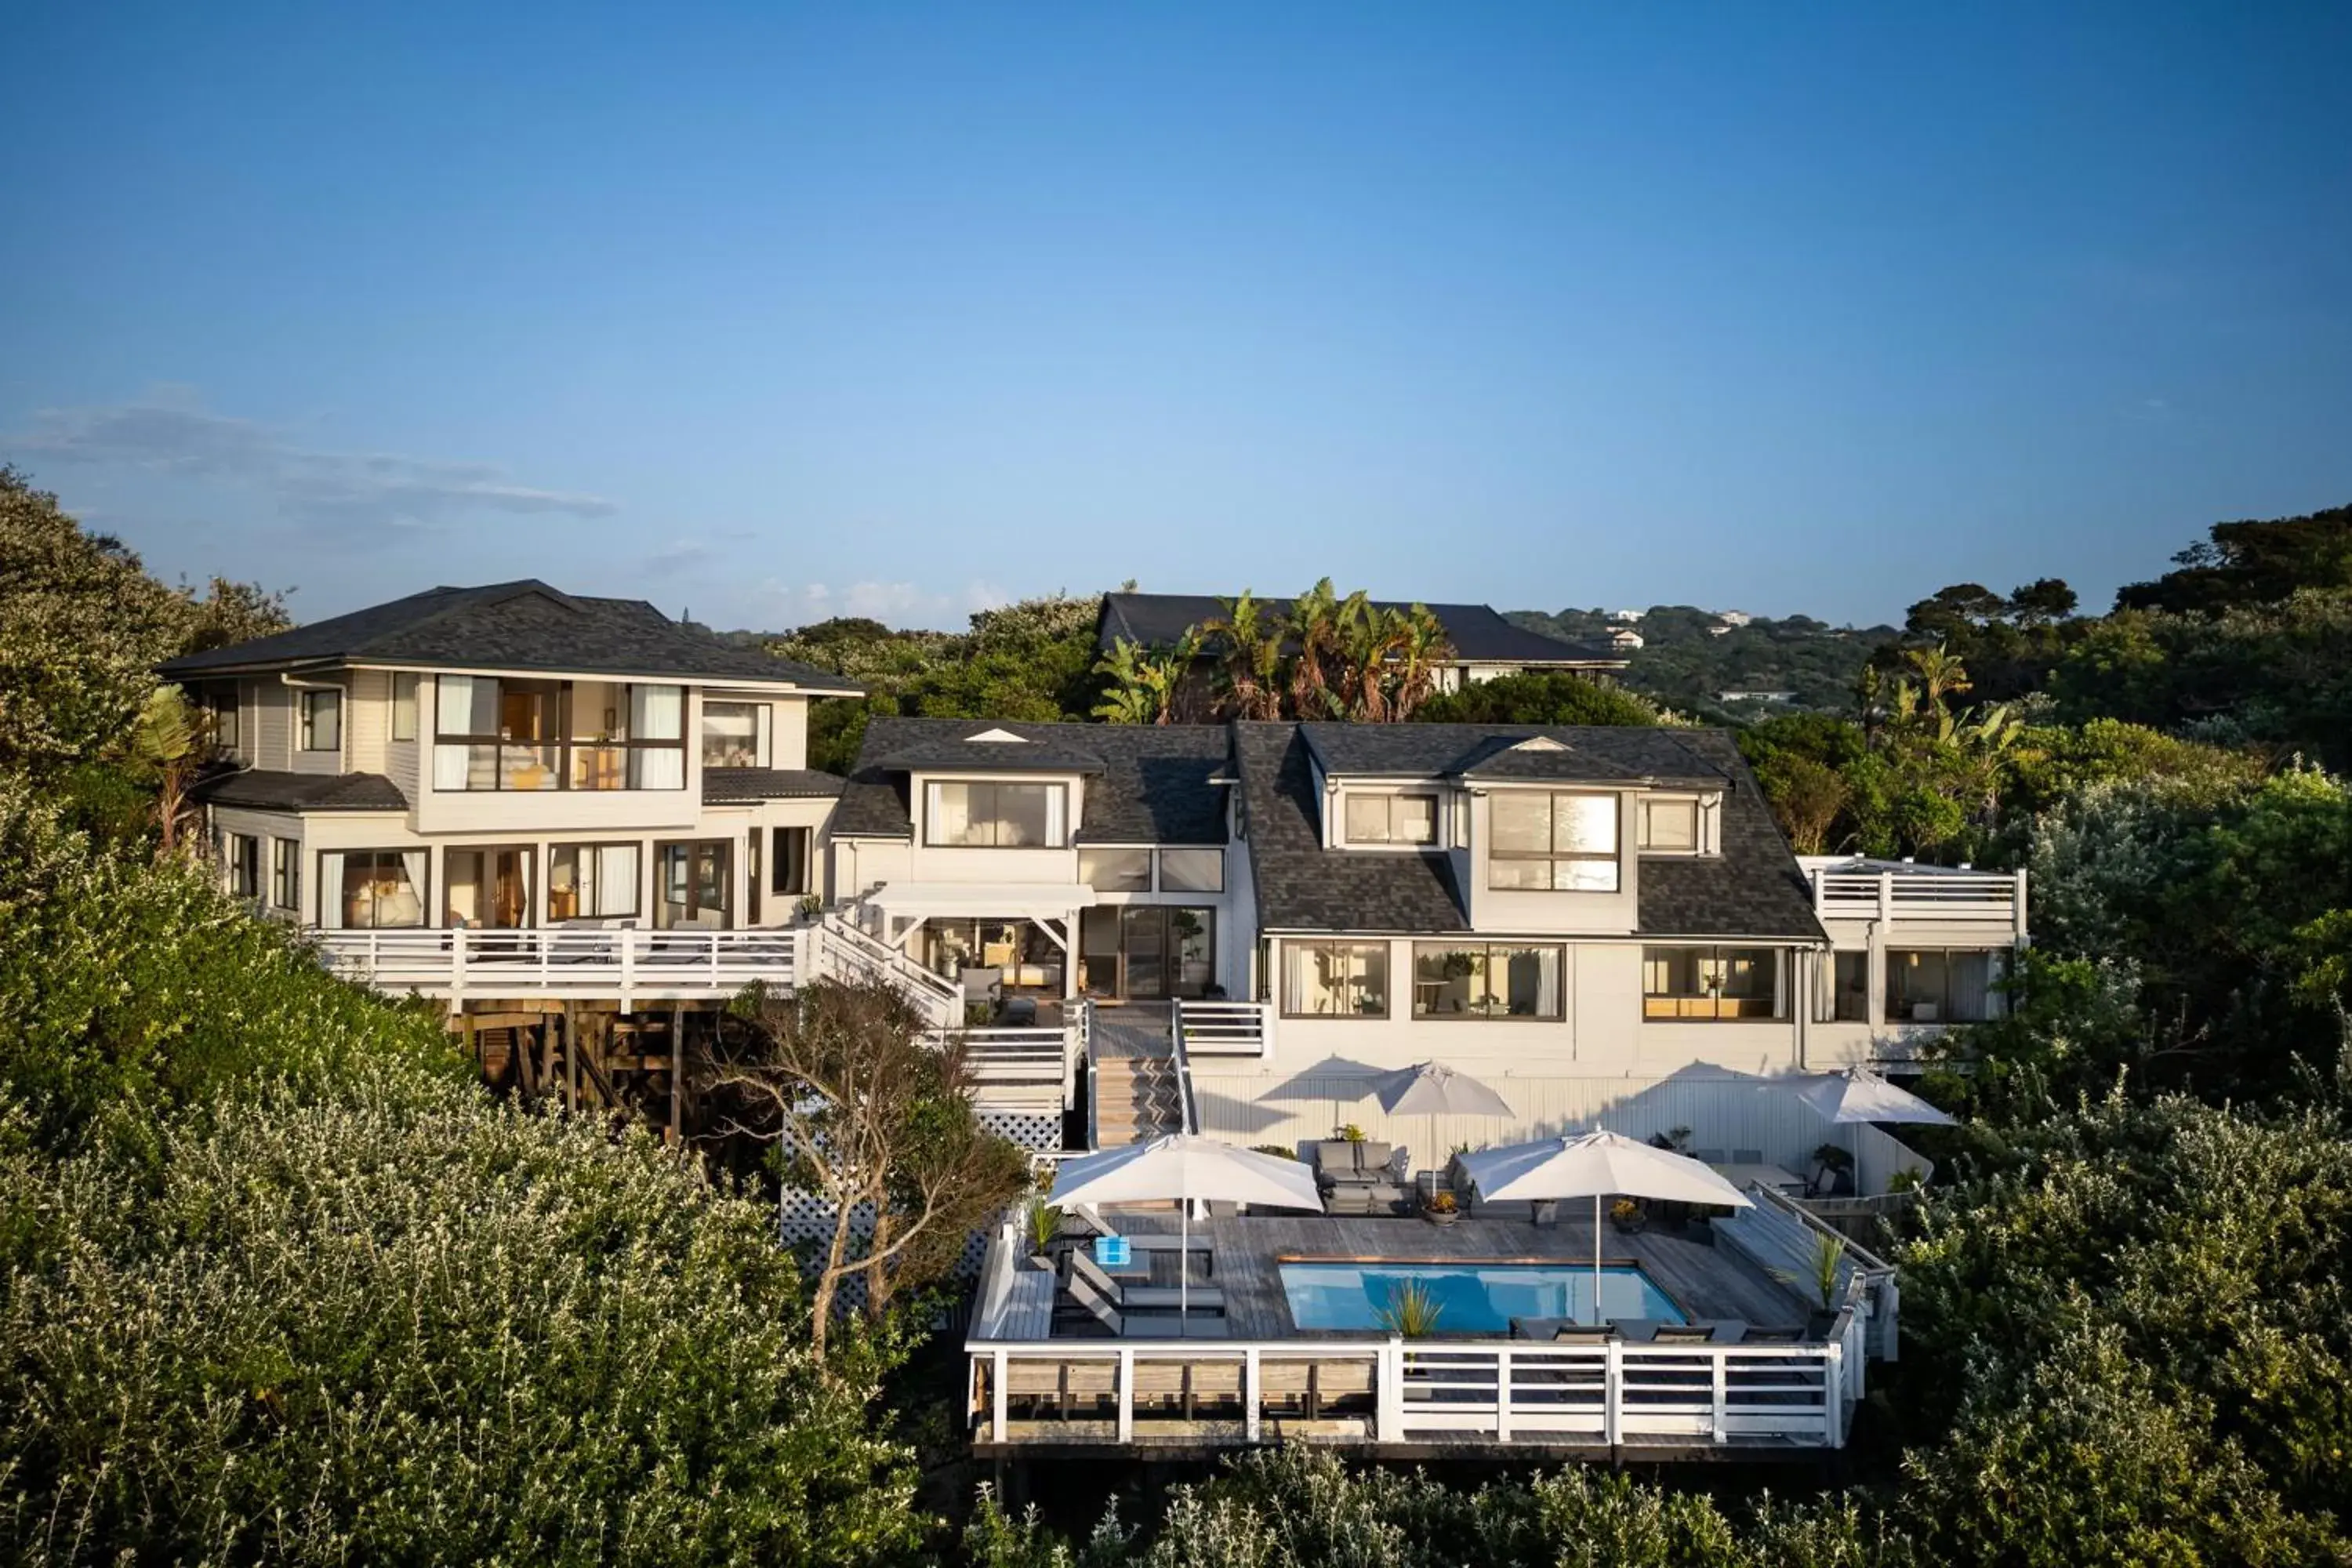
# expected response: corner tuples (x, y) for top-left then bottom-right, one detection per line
(1298, 724), (1724, 787)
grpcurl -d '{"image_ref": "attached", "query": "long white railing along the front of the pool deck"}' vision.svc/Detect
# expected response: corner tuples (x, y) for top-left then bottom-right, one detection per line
(967, 1326), (1858, 1448)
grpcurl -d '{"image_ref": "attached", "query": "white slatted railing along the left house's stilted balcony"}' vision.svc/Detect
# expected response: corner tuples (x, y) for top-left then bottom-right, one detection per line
(313, 926), (802, 1008)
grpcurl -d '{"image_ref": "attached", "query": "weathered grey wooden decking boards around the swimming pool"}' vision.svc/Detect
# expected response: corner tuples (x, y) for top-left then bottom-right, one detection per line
(1007, 1210), (1806, 1340)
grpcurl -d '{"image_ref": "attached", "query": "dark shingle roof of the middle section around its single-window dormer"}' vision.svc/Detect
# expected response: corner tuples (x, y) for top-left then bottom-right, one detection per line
(833, 720), (1228, 844)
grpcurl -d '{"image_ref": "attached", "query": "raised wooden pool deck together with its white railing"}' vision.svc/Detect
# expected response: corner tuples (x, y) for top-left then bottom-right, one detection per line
(967, 1208), (1893, 1457)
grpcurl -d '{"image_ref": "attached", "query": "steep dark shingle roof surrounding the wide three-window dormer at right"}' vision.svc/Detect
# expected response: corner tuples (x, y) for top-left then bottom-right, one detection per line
(1235, 724), (1828, 942)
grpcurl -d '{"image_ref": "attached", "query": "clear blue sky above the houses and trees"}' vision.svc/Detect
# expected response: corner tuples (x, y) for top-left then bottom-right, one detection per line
(0, 0), (2352, 626)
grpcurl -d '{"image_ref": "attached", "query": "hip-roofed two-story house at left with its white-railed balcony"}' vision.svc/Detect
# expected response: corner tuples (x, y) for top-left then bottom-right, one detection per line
(162, 581), (858, 1123)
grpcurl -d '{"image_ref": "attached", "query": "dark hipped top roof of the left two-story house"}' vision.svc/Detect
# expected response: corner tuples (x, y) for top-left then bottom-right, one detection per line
(162, 579), (858, 691)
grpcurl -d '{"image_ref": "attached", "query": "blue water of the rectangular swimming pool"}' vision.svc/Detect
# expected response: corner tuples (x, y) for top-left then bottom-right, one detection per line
(1282, 1262), (1684, 1333)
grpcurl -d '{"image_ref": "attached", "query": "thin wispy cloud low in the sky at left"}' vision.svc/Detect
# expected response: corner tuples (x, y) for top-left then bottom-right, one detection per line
(7, 393), (621, 534)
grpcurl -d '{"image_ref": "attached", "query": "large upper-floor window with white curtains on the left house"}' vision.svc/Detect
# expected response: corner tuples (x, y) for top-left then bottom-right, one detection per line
(433, 675), (687, 789)
